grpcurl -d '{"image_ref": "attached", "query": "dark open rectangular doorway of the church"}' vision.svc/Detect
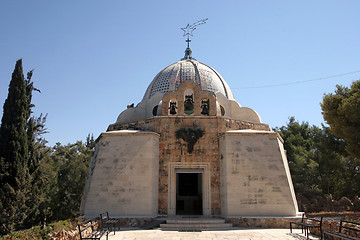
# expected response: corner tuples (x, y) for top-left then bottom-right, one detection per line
(176, 173), (203, 215)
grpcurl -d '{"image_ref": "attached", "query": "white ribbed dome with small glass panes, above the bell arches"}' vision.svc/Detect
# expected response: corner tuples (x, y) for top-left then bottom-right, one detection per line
(142, 59), (235, 101)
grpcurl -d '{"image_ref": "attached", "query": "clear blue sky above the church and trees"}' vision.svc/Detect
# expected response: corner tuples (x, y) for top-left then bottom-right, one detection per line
(0, 0), (360, 145)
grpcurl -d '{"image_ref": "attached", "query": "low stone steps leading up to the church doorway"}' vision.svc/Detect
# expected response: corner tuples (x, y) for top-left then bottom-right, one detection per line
(160, 217), (233, 231)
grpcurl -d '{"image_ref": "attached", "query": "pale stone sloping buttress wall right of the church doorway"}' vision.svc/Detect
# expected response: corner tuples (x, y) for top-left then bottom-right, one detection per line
(220, 130), (298, 217)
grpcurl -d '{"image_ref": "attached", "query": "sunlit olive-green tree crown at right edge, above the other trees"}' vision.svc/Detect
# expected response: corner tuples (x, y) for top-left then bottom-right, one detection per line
(321, 80), (360, 159)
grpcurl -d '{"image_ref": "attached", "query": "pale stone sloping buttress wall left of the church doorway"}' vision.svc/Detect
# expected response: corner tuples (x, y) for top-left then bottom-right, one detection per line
(81, 130), (159, 217)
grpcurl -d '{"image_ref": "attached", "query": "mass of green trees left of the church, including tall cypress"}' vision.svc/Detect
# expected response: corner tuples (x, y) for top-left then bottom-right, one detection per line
(0, 59), (95, 234)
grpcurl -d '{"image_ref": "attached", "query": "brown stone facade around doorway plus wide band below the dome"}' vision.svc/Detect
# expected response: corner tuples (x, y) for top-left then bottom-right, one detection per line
(108, 116), (270, 215)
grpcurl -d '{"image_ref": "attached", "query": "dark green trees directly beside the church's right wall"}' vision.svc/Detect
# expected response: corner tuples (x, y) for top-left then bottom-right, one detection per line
(274, 117), (360, 210)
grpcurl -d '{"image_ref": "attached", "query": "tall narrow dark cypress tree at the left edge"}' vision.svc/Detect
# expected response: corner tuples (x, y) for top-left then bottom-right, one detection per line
(0, 59), (30, 234)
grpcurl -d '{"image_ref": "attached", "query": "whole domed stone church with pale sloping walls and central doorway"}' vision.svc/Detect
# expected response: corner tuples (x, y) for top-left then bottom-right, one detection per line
(81, 34), (298, 218)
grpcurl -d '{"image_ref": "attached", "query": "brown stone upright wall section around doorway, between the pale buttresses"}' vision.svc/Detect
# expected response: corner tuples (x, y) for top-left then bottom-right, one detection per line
(159, 118), (220, 215)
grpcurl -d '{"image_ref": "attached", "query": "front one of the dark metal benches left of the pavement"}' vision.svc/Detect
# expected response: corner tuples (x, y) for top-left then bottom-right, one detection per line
(78, 219), (109, 240)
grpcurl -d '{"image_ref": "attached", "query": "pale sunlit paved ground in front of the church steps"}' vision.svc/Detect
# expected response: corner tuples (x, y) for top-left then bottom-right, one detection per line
(103, 229), (320, 240)
